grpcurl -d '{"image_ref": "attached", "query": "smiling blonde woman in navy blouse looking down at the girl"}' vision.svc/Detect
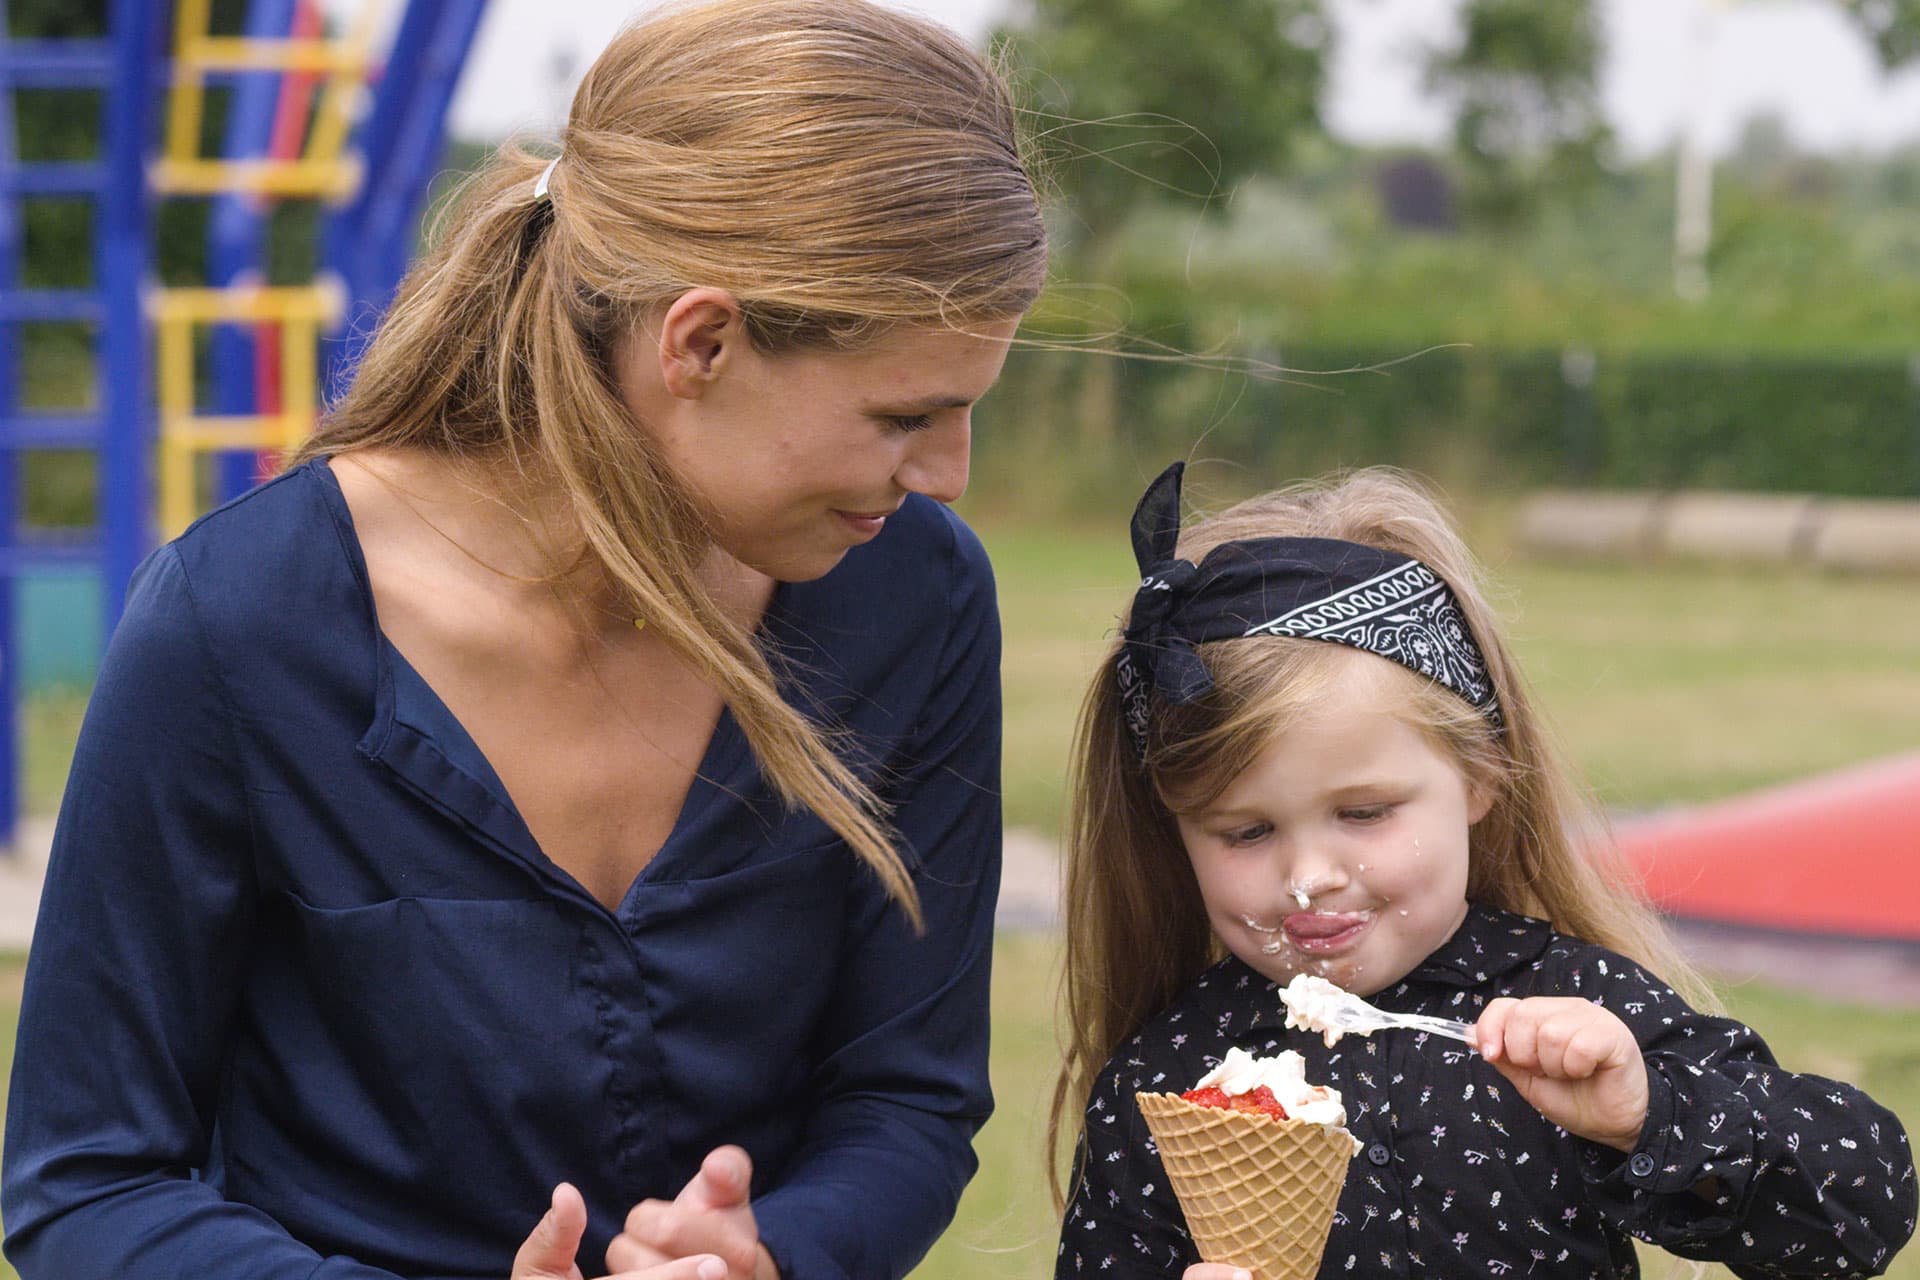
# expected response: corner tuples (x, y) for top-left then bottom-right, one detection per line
(4, 0), (1046, 1280)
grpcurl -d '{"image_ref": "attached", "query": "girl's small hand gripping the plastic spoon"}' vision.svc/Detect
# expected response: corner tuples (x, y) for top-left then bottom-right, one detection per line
(1473, 996), (1647, 1151)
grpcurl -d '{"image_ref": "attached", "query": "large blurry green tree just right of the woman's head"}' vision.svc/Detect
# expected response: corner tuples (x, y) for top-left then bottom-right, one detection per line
(995, 0), (1331, 276)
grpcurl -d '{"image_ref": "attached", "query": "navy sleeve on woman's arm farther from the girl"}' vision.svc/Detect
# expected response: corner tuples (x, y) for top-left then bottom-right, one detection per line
(0, 547), (401, 1280)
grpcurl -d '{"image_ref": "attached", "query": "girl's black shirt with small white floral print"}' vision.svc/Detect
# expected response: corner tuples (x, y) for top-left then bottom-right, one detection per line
(1054, 908), (1914, 1280)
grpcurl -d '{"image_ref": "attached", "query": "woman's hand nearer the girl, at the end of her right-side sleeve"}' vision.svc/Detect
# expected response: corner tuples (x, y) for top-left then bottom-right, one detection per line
(607, 1146), (780, 1280)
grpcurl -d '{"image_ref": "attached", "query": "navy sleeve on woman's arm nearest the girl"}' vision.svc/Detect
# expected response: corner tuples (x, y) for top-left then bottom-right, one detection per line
(755, 522), (1000, 1280)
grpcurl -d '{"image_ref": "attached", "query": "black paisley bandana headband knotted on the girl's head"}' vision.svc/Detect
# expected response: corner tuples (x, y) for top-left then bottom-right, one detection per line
(1116, 462), (1503, 758)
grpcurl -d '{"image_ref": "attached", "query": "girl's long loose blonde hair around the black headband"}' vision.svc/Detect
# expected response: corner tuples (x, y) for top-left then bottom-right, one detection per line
(1046, 468), (1715, 1203)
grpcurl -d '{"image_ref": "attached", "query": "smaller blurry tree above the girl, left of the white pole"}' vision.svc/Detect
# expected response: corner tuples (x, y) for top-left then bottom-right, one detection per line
(1427, 0), (1611, 226)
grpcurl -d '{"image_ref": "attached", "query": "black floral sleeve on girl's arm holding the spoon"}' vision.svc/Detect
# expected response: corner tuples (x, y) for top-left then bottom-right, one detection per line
(1582, 956), (1914, 1276)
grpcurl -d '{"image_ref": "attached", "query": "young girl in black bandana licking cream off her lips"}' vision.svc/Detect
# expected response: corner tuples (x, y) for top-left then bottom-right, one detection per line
(1050, 464), (1914, 1280)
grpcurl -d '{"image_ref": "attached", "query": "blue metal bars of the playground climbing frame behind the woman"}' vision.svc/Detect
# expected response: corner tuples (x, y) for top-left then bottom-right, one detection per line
(0, 0), (486, 848)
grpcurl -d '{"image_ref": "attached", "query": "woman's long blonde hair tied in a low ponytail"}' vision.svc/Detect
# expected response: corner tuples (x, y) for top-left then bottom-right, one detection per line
(292, 0), (1046, 927)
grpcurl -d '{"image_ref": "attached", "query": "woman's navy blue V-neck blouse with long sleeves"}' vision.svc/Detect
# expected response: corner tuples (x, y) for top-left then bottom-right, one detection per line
(0, 462), (1000, 1280)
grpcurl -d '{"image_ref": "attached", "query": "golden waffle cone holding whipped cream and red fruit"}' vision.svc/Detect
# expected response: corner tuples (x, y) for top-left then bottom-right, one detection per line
(1135, 1094), (1354, 1280)
